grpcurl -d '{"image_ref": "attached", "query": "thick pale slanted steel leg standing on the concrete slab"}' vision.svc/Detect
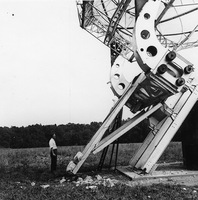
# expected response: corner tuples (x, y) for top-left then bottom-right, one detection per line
(130, 86), (198, 173)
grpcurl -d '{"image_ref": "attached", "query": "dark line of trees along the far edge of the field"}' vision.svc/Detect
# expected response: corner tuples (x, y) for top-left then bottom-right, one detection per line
(0, 111), (194, 148)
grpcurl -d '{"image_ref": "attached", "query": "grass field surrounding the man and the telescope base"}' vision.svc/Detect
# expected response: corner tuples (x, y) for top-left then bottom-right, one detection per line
(0, 143), (198, 200)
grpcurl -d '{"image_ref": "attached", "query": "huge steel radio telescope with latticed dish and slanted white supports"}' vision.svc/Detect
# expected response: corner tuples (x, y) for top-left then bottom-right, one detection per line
(67, 0), (198, 174)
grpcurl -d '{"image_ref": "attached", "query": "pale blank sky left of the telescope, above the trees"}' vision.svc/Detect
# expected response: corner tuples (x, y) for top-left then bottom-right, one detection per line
(0, 0), (197, 127)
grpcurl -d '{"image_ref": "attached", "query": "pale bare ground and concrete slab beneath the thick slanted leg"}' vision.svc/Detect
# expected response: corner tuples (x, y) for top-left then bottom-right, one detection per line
(75, 162), (198, 187)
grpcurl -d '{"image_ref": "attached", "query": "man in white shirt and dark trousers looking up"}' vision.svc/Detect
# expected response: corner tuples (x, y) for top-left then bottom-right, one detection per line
(49, 133), (57, 173)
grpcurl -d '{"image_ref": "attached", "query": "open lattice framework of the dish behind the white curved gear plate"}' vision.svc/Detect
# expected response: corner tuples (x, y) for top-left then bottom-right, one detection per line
(77, 0), (198, 63)
